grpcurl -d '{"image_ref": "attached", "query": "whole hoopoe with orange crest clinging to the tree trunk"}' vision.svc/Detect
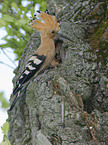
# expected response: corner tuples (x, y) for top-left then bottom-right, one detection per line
(10, 10), (70, 110)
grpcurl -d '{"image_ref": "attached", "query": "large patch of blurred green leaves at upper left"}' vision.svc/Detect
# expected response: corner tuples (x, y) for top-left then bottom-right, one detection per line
(0, 0), (47, 59)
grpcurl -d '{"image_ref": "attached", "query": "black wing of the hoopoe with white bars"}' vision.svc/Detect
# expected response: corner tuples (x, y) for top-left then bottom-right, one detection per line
(13, 54), (46, 95)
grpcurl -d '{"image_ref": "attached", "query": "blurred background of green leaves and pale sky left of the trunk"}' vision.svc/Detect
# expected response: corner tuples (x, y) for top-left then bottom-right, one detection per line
(0, 0), (47, 142)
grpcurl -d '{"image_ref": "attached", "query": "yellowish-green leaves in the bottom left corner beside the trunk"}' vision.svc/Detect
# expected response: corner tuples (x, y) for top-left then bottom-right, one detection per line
(0, 122), (11, 145)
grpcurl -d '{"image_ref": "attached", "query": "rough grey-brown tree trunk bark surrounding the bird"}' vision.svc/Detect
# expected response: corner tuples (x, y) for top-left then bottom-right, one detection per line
(8, 0), (108, 145)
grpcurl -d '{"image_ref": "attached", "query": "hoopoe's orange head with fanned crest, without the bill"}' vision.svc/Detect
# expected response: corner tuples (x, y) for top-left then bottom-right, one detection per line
(30, 12), (60, 39)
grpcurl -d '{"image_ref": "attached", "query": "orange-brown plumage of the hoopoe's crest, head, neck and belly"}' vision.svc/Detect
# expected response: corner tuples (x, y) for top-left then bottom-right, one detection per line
(31, 12), (59, 73)
